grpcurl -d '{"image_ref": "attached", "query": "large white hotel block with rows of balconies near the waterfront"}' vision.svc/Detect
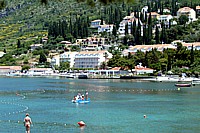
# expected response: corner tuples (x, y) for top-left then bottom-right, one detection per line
(74, 51), (112, 68)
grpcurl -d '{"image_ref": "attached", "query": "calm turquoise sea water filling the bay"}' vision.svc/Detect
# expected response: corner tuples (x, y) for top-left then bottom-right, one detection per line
(0, 77), (200, 133)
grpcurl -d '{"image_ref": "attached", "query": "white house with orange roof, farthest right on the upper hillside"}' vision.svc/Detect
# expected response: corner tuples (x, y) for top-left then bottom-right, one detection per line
(177, 7), (196, 22)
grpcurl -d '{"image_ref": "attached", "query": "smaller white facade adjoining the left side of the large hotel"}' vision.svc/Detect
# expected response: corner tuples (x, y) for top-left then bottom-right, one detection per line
(60, 52), (78, 68)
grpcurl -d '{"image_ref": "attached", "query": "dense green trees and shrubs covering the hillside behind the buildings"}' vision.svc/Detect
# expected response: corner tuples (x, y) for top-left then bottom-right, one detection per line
(0, 0), (200, 73)
